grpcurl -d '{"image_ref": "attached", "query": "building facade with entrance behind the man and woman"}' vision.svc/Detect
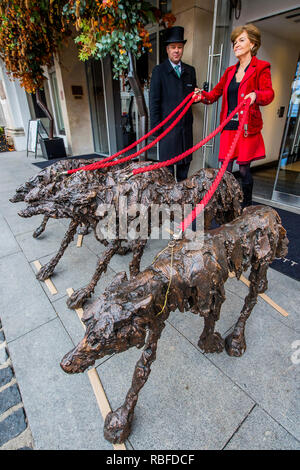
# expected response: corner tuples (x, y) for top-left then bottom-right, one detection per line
(0, 0), (300, 207)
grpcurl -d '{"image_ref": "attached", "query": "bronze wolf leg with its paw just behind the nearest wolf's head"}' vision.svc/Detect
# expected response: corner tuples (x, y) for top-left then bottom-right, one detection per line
(67, 240), (120, 309)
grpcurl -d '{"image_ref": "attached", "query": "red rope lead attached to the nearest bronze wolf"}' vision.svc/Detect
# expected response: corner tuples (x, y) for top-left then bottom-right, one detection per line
(180, 99), (250, 233)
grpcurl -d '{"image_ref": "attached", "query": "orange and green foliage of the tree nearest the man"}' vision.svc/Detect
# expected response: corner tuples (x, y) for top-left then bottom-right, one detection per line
(63, 0), (175, 77)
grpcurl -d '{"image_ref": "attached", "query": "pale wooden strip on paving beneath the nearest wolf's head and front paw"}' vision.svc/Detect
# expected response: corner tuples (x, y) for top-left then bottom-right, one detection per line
(67, 288), (127, 450)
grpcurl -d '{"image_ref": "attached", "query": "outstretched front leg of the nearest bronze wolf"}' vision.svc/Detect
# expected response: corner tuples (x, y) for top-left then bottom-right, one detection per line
(104, 324), (164, 444)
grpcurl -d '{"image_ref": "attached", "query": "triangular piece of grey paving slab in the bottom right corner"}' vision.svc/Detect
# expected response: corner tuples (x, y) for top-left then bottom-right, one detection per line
(225, 406), (300, 450)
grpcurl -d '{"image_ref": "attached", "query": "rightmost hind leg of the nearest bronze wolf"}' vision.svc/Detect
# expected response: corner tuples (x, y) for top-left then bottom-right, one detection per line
(225, 263), (268, 357)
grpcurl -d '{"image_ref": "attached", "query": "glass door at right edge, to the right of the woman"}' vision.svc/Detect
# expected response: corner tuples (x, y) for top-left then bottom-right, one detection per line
(272, 58), (300, 207)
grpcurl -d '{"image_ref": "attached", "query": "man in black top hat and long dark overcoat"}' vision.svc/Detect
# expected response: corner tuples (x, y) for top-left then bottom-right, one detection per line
(150, 26), (196, 181)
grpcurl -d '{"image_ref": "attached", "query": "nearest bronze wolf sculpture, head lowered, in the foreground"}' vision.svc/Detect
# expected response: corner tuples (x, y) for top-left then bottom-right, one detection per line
(61, 206), (288, 443)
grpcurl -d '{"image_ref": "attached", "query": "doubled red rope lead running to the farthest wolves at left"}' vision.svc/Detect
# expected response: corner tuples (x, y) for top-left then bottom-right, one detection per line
(68, 92), (194, 174)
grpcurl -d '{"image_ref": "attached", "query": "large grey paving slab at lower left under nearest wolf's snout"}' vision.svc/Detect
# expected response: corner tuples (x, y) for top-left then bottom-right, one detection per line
(10, 319), (112, 450)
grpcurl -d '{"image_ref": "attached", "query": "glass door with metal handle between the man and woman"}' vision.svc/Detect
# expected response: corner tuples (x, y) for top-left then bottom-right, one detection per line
(202, 0), (231, 168)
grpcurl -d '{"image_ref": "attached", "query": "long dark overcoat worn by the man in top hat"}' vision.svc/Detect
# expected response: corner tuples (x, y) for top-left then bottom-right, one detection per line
(149, 59), (197, 164)
